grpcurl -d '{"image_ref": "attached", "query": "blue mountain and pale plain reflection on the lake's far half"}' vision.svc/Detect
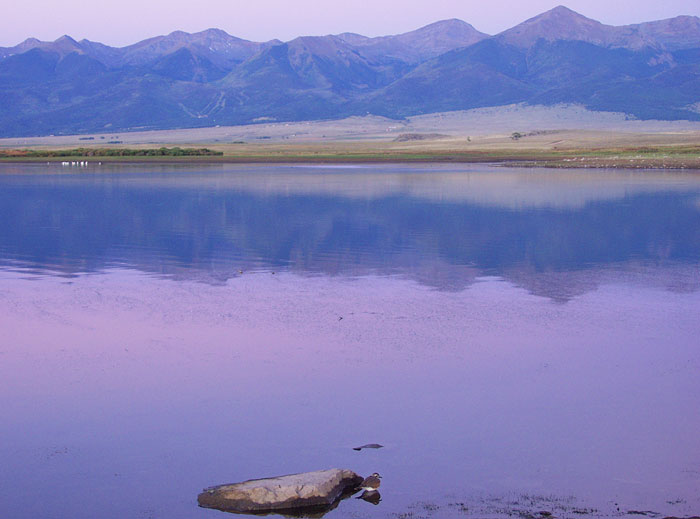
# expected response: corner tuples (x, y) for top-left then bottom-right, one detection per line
(0, 166), (700, 300)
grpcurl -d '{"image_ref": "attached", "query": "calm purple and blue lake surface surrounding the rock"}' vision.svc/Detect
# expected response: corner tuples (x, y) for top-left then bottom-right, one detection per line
(0, 165), (700, 519)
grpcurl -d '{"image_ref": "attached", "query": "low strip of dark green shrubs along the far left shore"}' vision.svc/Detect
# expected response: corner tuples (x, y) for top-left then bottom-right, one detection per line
(0, 146), (224, 158)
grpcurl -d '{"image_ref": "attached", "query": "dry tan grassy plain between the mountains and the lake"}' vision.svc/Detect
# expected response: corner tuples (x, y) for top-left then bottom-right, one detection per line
(0, 107), (700, 169)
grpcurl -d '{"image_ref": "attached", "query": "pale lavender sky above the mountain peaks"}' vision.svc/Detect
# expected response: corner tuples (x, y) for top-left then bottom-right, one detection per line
(0, 0), (700, 46)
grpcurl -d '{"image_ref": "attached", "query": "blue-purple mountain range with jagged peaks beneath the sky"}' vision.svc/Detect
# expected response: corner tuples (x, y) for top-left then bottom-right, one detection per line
(0, 6), (700, 137)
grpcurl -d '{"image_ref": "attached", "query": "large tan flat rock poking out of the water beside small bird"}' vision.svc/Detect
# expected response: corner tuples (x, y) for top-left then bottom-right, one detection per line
(197, 469), (362, 513)
